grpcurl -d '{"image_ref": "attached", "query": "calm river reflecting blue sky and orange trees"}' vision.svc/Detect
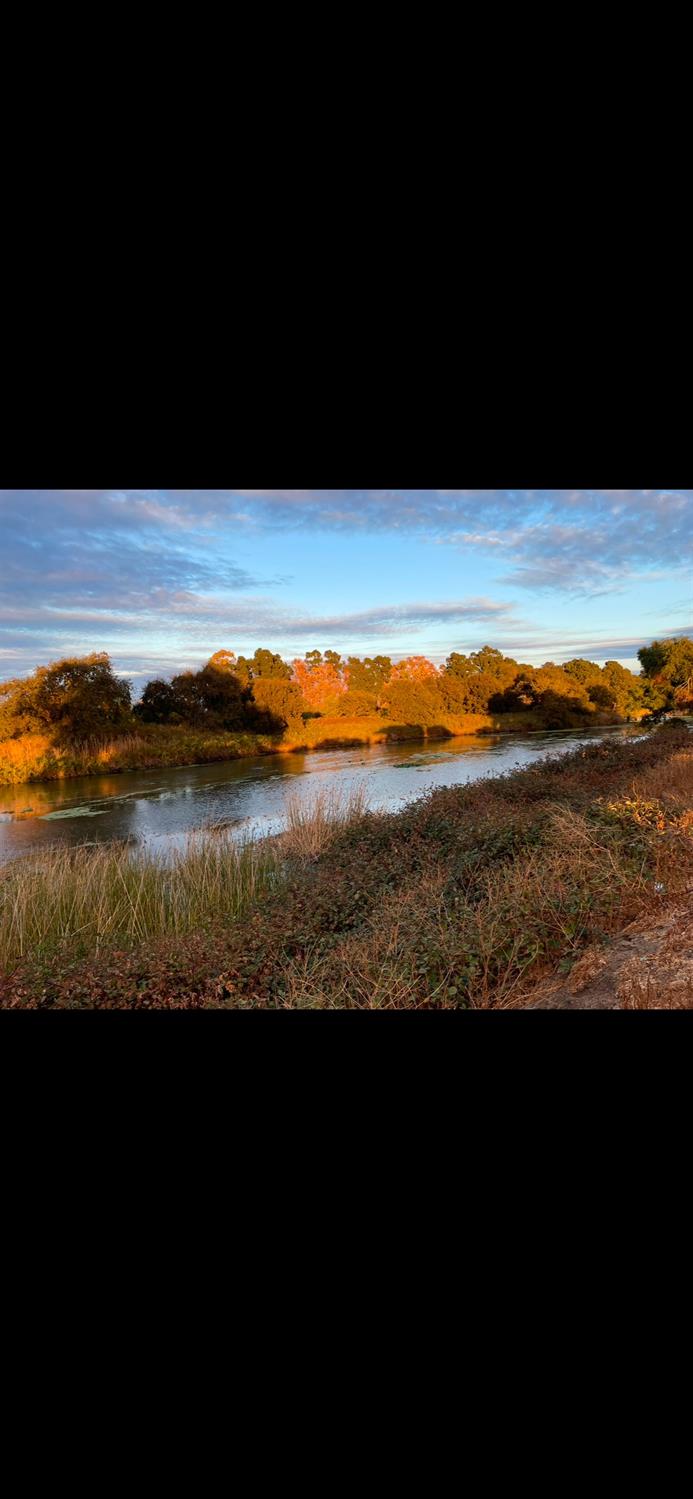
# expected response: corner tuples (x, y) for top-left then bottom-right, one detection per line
(0, 727), (651, 863)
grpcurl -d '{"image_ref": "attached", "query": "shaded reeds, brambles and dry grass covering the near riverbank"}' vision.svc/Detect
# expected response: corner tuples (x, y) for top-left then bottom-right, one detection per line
(0, 723), (693, 1009)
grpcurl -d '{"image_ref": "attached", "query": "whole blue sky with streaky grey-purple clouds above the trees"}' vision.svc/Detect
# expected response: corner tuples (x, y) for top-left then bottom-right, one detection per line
(0, 489), (693, 690)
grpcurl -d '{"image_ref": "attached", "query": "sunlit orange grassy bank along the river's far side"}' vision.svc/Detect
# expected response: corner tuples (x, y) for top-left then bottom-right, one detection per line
(0, 711), (623, 785)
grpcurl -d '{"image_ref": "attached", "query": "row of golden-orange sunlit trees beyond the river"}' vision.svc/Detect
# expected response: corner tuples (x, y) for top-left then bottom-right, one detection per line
(0, 636), (693, 744)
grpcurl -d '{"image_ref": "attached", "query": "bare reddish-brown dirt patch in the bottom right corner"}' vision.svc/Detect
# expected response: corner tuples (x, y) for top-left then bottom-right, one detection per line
(524, 890), (693, 1010)
